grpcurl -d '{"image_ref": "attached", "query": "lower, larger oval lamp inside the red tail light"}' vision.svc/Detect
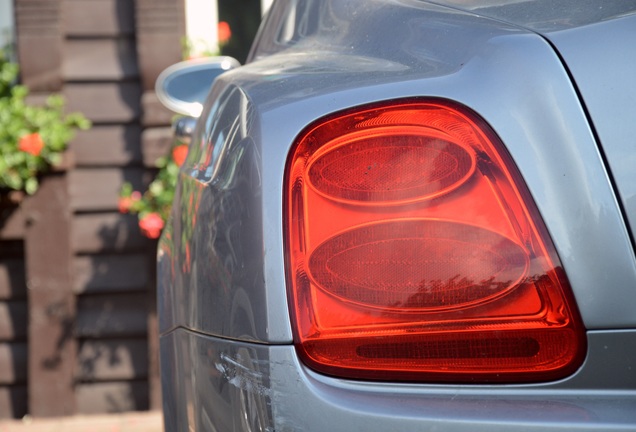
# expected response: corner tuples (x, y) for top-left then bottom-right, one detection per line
(308, 219), (527, 312)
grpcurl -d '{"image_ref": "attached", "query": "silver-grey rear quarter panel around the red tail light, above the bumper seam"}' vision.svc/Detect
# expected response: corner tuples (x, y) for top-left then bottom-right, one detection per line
(160, 1), (636, 343)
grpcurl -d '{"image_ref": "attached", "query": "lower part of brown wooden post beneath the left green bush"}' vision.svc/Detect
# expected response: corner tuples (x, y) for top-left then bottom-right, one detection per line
(25, 173), (77, 417)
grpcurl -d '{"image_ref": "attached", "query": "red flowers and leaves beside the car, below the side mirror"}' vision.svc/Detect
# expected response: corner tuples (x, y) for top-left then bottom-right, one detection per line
(119, 143), (188, 239)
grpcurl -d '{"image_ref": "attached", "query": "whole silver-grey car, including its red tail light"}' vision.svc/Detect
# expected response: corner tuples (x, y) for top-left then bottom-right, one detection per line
(158, 0), (636, 432)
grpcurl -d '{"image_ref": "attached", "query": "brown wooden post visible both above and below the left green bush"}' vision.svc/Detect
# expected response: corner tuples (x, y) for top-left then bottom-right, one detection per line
(15, 0), (71, 417)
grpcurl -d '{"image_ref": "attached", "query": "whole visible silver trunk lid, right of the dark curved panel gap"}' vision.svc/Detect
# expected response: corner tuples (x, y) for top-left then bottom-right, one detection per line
(436, 0), (636, 300)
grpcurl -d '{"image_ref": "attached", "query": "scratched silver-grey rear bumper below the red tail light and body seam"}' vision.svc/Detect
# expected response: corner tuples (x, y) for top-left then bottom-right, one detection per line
(161, 329), (636, 432)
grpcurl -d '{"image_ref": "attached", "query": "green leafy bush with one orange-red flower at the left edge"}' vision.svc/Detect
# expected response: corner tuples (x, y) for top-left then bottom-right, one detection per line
(0, 51), (90, 194)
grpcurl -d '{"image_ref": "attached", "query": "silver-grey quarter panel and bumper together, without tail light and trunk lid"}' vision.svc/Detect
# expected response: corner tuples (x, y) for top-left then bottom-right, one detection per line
(159, 0), (636, 431)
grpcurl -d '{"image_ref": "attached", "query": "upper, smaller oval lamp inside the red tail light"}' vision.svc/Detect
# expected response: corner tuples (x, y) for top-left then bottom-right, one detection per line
(307, 126), (475, 205)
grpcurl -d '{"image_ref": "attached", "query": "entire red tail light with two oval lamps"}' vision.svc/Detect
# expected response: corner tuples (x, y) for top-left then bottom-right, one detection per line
(285, 101), (585, 382)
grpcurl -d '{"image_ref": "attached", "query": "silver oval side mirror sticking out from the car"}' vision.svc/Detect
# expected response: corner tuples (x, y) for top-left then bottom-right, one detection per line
(155, 57), (240, 117)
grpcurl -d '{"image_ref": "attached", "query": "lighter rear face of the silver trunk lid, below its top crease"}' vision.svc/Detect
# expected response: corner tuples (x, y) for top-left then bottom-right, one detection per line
(548, 14), (636, 264)
